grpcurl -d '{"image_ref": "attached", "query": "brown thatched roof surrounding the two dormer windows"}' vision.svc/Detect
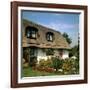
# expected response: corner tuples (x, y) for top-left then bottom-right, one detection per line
(22, 19), (70, 49)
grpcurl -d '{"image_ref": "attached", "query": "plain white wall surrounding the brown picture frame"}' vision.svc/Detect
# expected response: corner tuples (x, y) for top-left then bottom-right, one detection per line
(0, 0), (90, 90)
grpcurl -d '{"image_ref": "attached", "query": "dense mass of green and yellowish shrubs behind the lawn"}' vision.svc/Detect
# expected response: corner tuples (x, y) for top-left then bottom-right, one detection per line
(37, 57), (79, 75)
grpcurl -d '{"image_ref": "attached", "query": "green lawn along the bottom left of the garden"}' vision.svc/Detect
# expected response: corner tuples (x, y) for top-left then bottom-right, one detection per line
(22, 67), (60, 77)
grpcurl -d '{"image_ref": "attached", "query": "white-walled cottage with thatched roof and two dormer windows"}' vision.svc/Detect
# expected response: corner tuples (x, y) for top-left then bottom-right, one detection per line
(22, 20), (70, 61)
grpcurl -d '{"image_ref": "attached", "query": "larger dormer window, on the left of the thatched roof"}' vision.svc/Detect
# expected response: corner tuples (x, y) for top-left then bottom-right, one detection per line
(26, 26), (38, 39)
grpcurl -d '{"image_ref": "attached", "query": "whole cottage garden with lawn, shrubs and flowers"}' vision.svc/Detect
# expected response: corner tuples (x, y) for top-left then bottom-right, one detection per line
(22, 57), (79, 77)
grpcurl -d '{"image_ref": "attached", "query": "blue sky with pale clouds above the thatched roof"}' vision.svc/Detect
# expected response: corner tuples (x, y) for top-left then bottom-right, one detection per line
(22, 10), (79, 47)
